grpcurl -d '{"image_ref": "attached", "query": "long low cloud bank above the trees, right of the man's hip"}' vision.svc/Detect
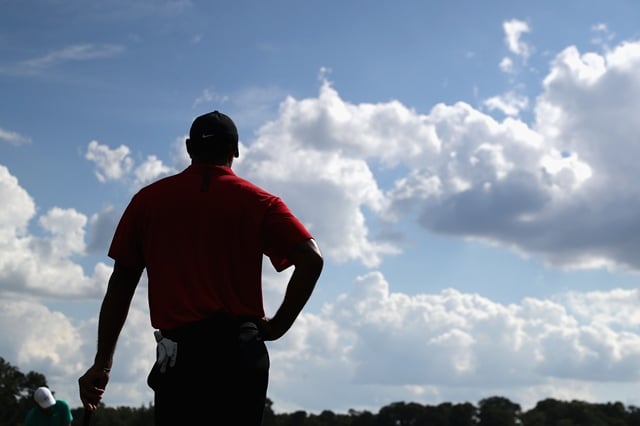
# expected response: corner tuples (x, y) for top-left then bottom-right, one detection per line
(270, 272), (640, 411)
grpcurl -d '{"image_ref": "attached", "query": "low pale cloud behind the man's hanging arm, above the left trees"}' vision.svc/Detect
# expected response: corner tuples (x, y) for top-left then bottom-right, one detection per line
(0, 281), (155, 407)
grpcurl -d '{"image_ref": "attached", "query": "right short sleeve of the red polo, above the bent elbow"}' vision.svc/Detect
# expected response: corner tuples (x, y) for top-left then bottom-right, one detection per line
(263, 197), (313, 272)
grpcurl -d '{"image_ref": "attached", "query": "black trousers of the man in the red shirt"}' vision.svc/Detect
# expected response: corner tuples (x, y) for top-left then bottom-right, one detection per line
(147, 317), (269, 426)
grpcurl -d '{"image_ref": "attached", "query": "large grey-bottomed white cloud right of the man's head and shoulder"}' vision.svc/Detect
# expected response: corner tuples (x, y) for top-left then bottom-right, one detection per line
(229, 76), (592, 266)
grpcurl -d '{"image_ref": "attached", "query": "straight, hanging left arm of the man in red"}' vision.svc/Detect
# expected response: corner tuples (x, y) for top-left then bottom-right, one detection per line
(78, 261), (144, 410)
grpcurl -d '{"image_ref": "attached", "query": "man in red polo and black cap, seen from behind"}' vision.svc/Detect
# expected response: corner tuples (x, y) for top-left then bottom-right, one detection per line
(78, 111), (323, 425)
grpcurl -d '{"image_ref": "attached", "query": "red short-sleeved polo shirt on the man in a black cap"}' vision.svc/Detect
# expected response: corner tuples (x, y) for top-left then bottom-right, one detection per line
(109, 164), (312, 329)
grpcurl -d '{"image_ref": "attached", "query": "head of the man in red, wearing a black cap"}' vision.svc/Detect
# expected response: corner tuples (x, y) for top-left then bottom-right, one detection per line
(186, 111), (239, 164)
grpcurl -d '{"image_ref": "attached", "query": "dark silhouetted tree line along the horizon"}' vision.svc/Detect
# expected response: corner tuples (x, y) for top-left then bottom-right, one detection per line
(0, 357), (640, 426)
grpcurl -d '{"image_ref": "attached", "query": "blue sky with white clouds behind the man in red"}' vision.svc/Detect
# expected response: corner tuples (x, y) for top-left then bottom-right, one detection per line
(0, 0), (640, 412)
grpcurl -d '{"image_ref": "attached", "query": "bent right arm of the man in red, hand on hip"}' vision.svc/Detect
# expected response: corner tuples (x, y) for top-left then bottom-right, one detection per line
(260, 238), (324, 340)
